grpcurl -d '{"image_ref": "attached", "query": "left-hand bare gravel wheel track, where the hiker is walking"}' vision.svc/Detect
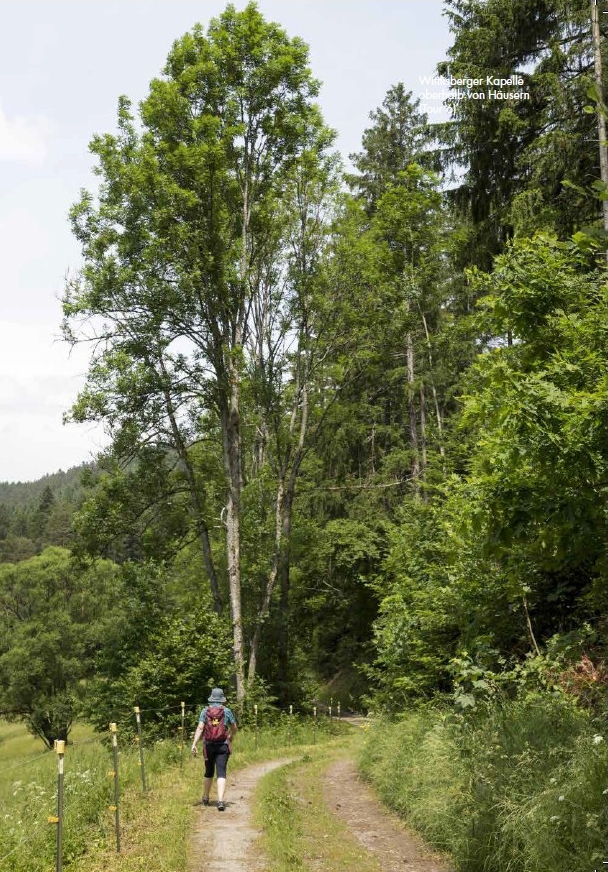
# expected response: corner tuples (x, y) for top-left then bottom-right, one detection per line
(188, 759), (291, 872)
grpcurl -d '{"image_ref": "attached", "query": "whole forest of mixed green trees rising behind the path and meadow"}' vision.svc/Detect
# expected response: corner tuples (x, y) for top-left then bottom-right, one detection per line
(0, 0), (608, 869)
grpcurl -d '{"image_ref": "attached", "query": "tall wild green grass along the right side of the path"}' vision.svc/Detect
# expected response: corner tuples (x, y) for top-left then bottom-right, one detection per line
(360, 694), (608, 872)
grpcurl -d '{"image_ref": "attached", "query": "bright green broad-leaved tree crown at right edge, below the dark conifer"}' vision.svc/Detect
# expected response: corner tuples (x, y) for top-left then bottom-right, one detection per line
(463, 239), (608, 634)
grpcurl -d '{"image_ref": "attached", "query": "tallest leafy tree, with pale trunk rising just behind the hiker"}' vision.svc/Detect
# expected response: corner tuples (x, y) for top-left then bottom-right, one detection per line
(65, 4), (328, 702)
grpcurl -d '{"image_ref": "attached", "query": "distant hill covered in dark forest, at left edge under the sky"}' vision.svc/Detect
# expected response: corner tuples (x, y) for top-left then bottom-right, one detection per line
(0, 464), (91, 563)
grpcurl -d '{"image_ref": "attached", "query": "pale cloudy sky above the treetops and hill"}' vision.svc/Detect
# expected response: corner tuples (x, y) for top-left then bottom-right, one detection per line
(0, 0), (450, 481)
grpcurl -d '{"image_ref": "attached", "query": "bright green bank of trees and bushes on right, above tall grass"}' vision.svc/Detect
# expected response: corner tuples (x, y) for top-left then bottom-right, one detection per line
(372, 238), (608, 708)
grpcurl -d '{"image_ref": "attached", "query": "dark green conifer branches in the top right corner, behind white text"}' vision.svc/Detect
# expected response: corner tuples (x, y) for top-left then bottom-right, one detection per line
(438, 0), (606, 269)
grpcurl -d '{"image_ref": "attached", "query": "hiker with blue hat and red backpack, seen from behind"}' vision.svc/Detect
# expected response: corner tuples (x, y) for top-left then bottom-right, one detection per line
(192, 687), (237, 811)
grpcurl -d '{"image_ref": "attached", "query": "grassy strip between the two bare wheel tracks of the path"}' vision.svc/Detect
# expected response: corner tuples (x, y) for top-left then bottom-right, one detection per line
(255, 735), (382, 872)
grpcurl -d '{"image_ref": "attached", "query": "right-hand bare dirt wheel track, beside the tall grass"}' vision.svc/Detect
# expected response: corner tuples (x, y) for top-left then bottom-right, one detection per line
(325, 758), (451, 872)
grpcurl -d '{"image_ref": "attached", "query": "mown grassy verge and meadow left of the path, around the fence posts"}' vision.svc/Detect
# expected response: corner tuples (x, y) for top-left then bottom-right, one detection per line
(0, 723), (346, 872)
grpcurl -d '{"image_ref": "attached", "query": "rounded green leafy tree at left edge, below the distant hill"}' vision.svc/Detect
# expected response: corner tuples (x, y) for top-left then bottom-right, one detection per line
(0, 547), (121, 747)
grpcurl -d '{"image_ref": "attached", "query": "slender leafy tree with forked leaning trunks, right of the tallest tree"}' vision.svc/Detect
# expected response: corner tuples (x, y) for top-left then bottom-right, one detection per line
(243, 146), (344, 696)
